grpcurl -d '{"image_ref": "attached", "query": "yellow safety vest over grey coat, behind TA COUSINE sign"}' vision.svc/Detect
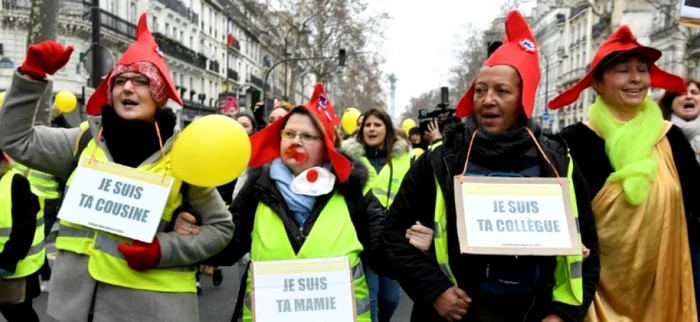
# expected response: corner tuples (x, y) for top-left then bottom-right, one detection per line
(56, 139), (197, 293)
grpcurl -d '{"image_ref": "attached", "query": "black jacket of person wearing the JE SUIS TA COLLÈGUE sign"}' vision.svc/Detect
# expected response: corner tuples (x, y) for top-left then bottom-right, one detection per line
(383, 124), (600, 321)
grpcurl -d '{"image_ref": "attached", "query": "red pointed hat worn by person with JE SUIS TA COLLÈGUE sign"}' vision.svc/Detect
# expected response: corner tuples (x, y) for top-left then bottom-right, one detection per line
(455, 10), (540, 118)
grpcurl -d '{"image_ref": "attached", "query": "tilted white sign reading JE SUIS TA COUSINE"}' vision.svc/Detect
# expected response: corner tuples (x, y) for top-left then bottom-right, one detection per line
(58, 158), (173, 243)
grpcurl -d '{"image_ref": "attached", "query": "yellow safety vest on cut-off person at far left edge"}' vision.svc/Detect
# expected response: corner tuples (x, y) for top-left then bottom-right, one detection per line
(0, 171), (46, 279)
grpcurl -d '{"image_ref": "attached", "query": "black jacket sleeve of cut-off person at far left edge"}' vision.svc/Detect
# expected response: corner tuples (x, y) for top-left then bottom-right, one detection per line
(0, 172), (44, 273)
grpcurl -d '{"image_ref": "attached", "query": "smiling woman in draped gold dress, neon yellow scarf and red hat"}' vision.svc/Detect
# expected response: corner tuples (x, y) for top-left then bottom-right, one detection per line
(549, 25), (700, 321)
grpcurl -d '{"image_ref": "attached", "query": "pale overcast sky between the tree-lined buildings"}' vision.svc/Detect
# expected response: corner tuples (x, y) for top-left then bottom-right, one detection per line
(373, 0), (525, 117)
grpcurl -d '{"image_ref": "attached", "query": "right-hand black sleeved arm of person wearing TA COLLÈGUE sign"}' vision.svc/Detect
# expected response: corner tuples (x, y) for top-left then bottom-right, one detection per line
(552, 160), (600, 321)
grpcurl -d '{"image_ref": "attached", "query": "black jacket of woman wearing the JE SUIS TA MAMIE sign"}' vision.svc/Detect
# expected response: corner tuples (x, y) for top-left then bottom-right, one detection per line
(205, 156), (386, 271)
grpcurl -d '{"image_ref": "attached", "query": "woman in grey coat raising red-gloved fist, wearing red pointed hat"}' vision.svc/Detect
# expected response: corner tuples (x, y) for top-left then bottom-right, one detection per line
(0, 14), (233, 321)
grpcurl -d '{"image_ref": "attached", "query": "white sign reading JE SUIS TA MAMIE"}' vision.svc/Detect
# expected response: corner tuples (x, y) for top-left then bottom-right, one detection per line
(252, 257), (355, 322)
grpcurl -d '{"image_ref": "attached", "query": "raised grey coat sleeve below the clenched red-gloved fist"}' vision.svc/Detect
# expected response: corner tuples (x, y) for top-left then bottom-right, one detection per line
(0, 71), (80, 179)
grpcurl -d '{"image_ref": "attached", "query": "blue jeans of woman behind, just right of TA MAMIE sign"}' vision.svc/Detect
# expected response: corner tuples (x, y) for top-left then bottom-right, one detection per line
(365, 265), (401, 322)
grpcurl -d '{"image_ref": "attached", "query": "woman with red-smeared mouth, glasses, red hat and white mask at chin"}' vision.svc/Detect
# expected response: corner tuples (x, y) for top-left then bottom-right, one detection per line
(191, 84), (385, 322)
